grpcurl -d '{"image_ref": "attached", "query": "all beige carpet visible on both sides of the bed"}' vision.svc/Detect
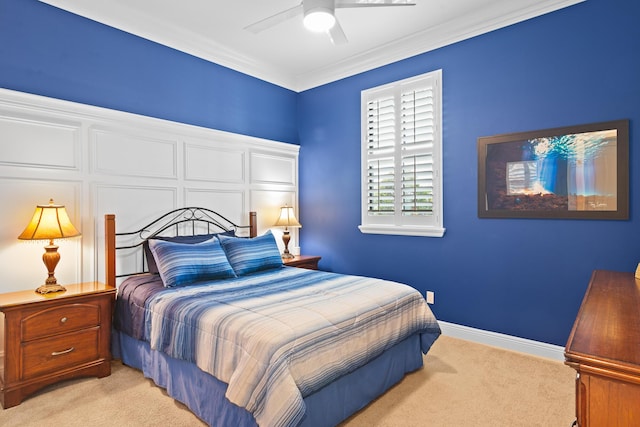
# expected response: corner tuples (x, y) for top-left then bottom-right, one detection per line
(0, 337), (574, 427)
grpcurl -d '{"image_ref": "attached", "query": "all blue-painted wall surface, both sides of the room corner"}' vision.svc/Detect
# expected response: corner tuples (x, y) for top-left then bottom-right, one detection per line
(0, 0), (640, 345)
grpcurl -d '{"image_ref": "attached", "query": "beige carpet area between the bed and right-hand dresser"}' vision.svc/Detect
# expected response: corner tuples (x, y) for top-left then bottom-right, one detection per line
(343, 337), (575, 427)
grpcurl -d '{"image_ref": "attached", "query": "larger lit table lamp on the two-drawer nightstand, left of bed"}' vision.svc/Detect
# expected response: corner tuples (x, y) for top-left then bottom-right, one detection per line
(18, 199), (80, 294)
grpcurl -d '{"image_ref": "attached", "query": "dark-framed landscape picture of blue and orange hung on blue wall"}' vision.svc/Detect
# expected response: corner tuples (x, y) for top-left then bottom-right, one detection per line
(478, 120), (629, 219)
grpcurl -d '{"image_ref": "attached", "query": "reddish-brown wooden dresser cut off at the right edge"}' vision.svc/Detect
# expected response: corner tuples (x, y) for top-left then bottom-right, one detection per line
(565, 270), (640, 427)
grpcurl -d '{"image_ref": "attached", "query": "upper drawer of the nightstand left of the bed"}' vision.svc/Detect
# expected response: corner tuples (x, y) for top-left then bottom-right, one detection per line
(21, 304), (100, 342)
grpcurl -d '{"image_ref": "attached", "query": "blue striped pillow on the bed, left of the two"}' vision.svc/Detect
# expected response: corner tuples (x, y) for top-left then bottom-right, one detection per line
(149, 238), (236, 288)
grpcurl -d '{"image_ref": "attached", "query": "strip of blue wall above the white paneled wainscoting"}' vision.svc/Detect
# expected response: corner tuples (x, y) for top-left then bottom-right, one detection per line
(0, 0), (299, 144)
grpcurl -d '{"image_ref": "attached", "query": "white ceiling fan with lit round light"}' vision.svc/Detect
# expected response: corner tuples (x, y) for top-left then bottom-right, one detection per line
(245, 0), (416, 45)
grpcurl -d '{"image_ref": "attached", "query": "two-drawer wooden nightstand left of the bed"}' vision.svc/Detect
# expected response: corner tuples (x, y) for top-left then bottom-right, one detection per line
(0, 282), (116, 409)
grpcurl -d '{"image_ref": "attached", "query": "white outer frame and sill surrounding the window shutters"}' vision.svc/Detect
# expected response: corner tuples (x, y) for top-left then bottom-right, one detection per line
(358, 70), (446, 237)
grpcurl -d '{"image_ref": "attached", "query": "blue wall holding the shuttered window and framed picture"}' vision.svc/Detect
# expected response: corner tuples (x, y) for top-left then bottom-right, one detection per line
(299, 0), (640, 345)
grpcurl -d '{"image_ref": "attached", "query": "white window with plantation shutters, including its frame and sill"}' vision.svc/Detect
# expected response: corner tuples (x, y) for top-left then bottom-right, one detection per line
(359, 70), (445, 237)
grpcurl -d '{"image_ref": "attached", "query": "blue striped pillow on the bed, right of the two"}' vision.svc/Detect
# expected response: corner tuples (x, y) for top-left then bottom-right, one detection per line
(218, 230), (282, 276)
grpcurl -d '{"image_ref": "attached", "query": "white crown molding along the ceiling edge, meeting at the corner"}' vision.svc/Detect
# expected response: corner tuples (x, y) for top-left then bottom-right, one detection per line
(40, 0), (586, 92)
